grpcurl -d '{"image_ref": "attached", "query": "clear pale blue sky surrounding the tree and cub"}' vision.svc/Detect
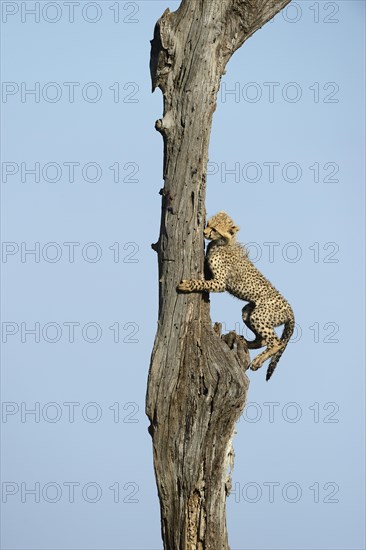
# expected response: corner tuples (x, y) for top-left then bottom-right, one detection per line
(1, 0), (365, 550)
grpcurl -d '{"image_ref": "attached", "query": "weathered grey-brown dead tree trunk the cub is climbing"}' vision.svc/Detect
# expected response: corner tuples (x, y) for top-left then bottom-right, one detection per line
(146, 0), (290, 550)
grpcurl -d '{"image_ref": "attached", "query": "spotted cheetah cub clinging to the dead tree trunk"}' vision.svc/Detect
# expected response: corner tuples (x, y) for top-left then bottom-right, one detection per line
(177, 212), (295, 380)
